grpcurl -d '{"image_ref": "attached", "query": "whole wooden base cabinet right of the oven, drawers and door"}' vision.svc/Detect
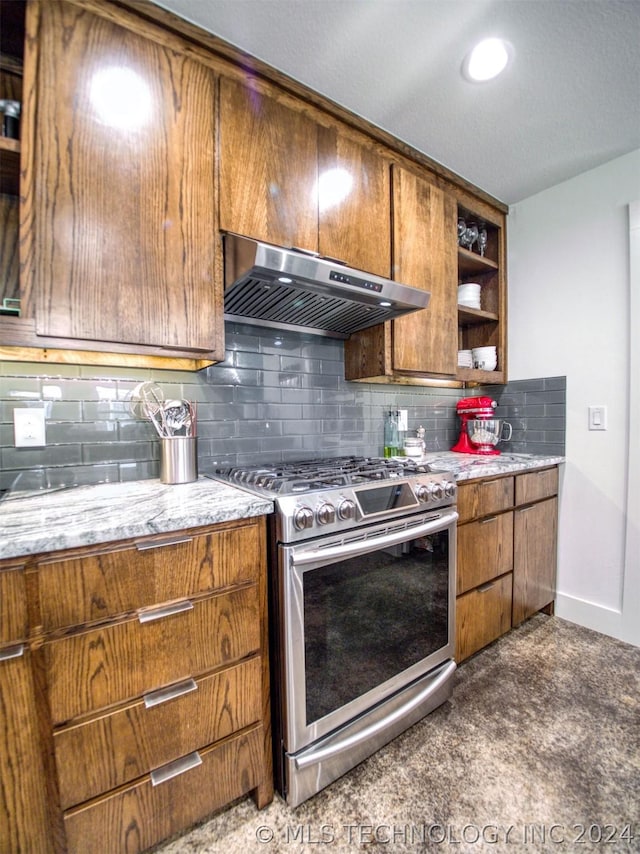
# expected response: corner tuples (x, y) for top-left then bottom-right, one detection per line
(456, 466), (558, 662)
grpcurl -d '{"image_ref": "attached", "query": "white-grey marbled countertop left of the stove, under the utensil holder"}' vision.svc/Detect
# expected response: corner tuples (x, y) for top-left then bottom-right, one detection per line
(0, 477), (273, 558)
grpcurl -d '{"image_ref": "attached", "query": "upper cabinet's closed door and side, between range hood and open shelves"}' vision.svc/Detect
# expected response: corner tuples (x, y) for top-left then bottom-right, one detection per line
(345, 166), (458, 382)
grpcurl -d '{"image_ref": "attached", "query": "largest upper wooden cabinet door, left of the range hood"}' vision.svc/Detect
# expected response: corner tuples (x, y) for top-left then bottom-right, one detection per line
(34, 2), (221, 351)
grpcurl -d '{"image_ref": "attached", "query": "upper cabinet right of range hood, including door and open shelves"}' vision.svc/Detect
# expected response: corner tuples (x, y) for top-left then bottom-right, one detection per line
(345, 169), (506, 386)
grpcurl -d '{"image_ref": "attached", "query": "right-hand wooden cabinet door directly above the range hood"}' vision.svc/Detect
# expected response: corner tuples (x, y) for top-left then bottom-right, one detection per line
(318, 127), (391, 277)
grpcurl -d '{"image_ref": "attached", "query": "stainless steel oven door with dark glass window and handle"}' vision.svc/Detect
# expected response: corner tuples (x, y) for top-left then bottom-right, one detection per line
(279, 508), (458, 754)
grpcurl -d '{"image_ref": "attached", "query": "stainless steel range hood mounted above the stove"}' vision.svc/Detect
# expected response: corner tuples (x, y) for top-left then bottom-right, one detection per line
(223, 234), (430, 338)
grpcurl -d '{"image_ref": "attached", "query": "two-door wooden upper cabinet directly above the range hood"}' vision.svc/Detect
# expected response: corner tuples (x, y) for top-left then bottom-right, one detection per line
(220, 77), (391, 276)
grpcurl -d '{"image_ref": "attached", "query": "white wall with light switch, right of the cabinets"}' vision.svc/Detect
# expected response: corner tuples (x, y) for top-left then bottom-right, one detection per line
(508, 150), (640, 643)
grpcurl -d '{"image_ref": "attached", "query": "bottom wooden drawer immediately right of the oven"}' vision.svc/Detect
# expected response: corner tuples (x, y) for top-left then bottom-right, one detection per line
(456, 573), (513, 663)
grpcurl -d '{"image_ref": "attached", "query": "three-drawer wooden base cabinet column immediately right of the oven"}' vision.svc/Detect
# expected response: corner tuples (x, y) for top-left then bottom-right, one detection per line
(456, 477), (514, 662)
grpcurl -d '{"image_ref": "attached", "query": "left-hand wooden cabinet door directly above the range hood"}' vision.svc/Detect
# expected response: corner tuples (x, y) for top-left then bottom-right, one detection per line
(220, 78), (318, 252)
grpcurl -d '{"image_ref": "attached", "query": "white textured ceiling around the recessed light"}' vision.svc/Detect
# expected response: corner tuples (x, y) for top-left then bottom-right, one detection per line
(156, 0), (640, 204)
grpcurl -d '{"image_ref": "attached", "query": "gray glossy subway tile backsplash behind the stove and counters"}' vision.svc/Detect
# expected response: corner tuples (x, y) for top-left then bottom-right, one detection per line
(0, 324), (566, 488)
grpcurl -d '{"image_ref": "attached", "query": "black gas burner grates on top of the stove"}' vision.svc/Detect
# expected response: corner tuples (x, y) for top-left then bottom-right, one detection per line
(215, 457), (427, 495)
